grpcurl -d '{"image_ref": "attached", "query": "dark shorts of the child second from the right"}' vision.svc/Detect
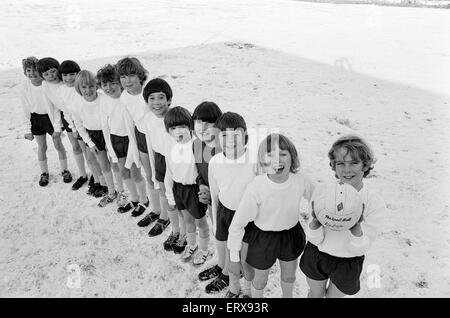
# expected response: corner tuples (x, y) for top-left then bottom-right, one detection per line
(246, 223), (306, 270)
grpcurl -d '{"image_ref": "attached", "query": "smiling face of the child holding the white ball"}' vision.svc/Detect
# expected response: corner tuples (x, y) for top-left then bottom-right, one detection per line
(335, 148), (367, 191)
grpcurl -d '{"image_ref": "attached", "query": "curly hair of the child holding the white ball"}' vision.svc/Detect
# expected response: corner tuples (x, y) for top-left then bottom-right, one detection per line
(328, 135), (375, 178)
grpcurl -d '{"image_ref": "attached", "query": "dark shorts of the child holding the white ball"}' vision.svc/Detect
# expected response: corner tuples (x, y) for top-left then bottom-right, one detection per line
(300, 242), (364, 295)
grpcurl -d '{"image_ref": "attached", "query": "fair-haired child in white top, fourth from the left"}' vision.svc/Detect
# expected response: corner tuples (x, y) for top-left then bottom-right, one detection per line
(72, 70), (117, 207)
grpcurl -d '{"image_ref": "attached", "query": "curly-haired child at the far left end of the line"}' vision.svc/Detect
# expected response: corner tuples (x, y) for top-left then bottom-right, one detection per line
(20, 56), (65, 187)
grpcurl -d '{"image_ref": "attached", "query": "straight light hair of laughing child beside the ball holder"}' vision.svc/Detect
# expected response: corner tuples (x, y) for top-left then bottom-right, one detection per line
(258, 134), (300, 173)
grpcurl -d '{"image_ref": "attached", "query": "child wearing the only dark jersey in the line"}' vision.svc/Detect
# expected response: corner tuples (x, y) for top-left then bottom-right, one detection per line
(192, 101), (224, 281)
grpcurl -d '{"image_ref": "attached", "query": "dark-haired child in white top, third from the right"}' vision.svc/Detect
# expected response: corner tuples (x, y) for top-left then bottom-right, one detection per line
(206, 112), (257, 298)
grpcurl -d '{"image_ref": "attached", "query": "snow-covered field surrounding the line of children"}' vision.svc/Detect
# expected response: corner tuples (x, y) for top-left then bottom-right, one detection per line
(0, 0), (450, 297)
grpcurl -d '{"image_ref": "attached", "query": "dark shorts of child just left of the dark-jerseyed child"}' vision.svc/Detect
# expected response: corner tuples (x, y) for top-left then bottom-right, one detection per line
(172, 182), (207, 220)
